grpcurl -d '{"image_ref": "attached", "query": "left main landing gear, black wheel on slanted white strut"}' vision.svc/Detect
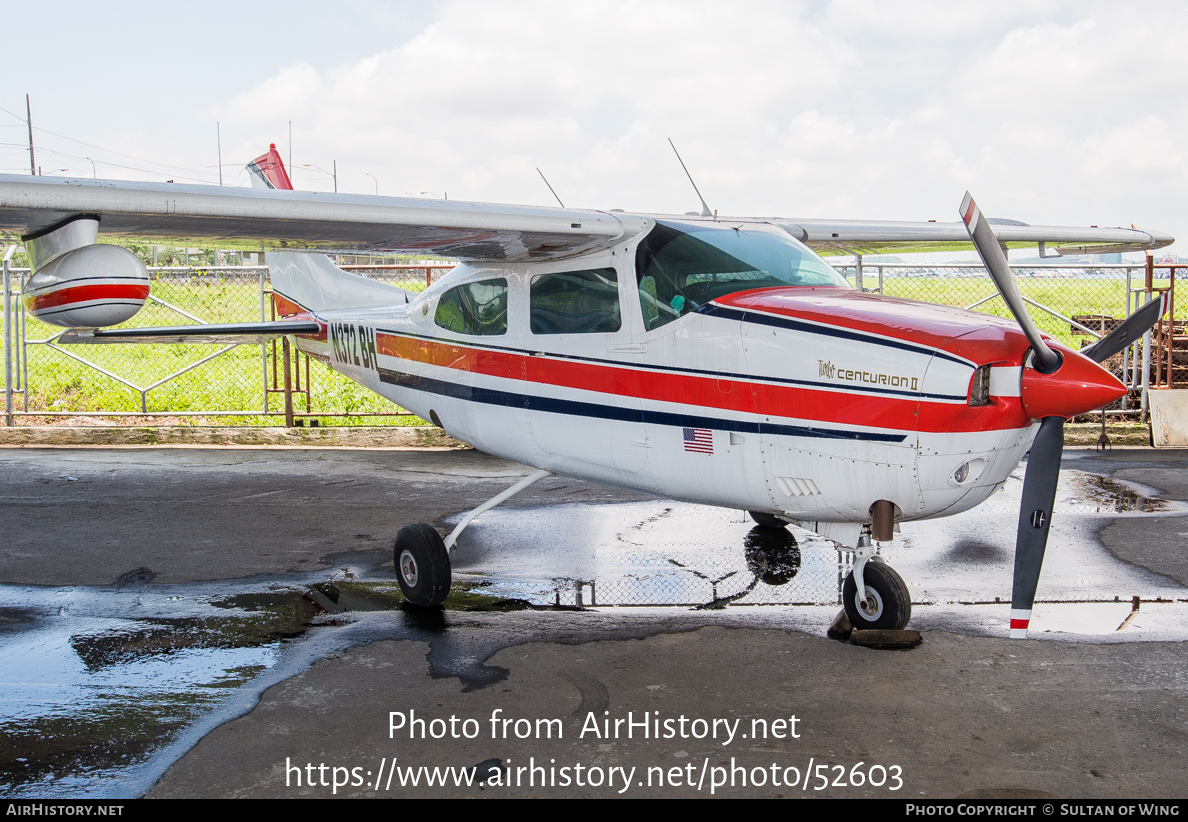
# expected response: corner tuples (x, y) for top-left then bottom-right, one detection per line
(392, 470), (552, 608)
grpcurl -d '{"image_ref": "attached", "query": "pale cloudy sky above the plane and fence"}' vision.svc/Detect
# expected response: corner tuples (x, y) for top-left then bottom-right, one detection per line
(0, 0), (1188, 253)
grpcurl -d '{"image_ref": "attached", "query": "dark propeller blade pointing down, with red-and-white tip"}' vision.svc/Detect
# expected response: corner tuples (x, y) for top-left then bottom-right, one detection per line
(1011, 417), (1064, 639)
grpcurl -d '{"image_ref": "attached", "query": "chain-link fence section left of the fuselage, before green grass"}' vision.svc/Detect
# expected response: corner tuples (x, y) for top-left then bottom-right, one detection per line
(6, 261), (453, 424)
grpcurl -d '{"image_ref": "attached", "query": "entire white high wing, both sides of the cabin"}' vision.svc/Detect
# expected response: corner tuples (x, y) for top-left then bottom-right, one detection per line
(0, 175), (1174, 260)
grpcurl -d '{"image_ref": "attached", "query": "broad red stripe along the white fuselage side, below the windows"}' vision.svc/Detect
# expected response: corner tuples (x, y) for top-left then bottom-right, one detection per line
(377, 333), (1030, 431)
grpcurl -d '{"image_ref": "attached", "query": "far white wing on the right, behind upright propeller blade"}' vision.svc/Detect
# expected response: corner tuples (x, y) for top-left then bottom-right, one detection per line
(772, 220), (1175, 254)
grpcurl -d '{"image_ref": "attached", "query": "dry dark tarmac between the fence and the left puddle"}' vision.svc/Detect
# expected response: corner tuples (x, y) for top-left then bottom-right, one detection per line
(0, 448), (652, 586)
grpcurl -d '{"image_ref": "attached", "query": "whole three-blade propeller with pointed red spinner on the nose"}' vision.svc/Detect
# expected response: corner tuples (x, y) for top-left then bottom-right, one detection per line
(961, 191), (1164, 638)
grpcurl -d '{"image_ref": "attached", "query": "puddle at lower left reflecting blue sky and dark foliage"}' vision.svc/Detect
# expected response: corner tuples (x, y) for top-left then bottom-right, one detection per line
(0, 569), (563, 797)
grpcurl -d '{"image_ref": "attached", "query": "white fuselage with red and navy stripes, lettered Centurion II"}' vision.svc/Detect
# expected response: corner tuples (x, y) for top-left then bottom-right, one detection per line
(289, 223), (1078, 542)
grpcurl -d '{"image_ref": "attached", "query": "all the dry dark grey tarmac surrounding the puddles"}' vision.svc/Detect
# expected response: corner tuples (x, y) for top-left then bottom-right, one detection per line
(0, 448), (1188, 798)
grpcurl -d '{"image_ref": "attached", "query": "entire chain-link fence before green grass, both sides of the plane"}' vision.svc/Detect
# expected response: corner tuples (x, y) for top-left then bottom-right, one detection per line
(5, 251), (1188, 424)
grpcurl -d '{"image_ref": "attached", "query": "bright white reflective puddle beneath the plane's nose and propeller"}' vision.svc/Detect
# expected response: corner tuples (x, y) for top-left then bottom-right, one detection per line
(454, 469), (1188, 607)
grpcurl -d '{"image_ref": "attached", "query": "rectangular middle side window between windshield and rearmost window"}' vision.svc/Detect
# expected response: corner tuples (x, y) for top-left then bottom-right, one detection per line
(530, 268), (623, 334)
